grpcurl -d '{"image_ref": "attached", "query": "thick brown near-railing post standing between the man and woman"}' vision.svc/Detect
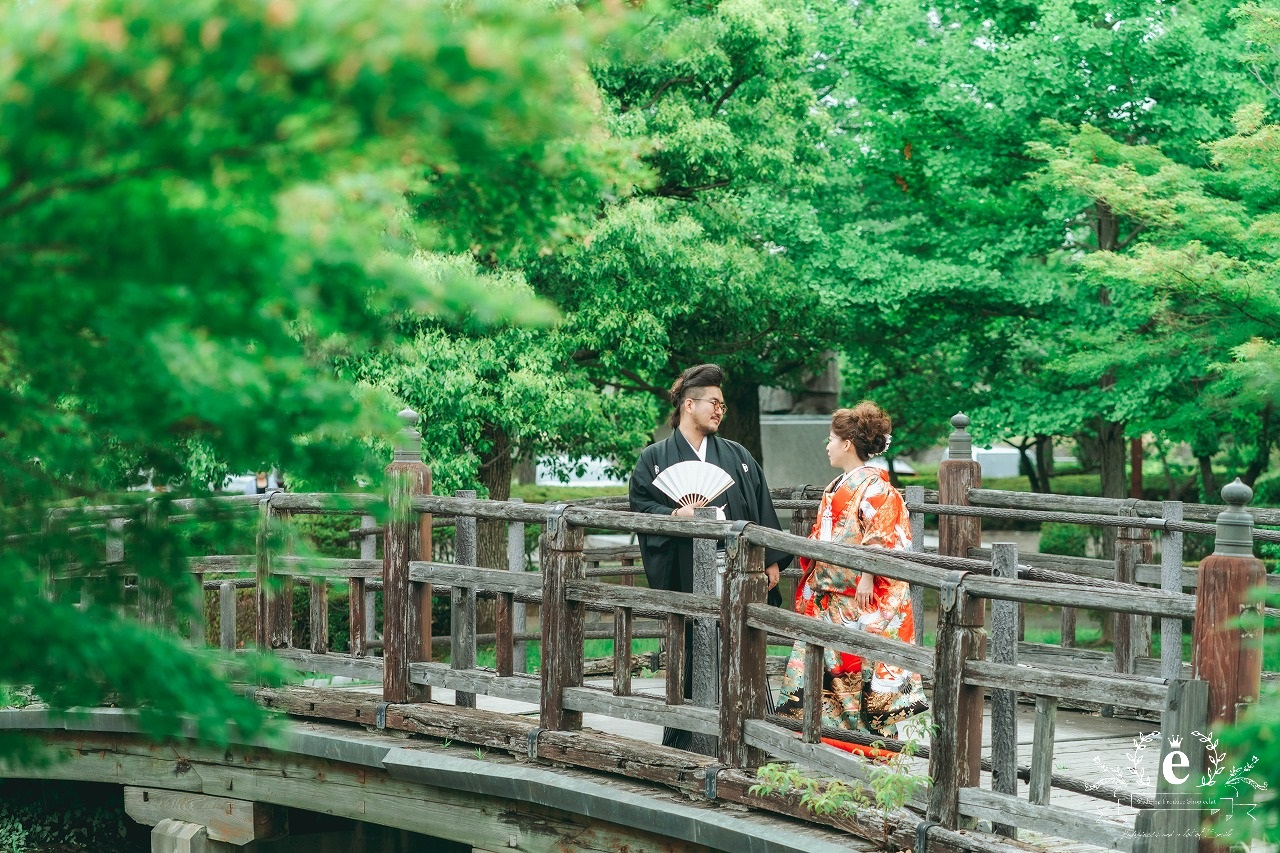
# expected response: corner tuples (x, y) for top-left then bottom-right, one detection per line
(719, 533), (769, 770)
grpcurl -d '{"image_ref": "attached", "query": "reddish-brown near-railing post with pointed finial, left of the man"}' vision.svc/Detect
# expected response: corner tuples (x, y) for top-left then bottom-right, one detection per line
(383, 409), (431, 702)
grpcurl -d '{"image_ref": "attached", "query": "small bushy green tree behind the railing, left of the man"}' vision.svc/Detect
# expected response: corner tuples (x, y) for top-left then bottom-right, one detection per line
(344, 256), (655, 569)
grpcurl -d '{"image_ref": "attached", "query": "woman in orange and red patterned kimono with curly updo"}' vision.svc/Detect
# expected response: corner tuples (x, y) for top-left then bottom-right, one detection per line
(778, 402), (929, 754)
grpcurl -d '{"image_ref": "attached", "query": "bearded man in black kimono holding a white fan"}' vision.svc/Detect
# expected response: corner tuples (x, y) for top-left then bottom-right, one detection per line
(630, 364), (791, 749)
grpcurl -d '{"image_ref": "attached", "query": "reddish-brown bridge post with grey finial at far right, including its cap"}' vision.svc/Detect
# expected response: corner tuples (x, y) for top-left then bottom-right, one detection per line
(1192, 478), (1266, 725)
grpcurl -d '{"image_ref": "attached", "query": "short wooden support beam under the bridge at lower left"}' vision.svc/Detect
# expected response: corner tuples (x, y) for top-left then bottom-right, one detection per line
(124, 785), (289, 847)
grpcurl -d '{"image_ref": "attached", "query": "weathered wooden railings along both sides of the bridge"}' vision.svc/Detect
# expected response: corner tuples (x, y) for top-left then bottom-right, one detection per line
(35, 407), (1280, 850)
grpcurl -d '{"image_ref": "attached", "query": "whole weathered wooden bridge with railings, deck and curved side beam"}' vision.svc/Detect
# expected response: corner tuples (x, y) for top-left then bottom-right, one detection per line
(0, 412), (1280, 853)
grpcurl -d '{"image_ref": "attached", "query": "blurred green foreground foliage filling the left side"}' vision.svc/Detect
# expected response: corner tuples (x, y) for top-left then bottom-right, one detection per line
(0, 0), (640, 752)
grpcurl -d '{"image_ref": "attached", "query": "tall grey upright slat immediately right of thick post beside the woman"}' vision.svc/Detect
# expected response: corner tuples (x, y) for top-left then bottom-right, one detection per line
(987, 543), (1018, 838)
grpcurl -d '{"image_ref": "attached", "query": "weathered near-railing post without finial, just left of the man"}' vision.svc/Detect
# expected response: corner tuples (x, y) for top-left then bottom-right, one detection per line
(539, 503), (586, 731)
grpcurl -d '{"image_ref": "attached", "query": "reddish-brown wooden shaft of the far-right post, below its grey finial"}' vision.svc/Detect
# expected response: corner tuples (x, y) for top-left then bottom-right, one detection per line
(1192, 553), (1265, 725)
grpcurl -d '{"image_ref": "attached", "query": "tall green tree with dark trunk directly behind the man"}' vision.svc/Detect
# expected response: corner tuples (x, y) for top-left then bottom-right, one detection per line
(529, 0), (831, 457)
